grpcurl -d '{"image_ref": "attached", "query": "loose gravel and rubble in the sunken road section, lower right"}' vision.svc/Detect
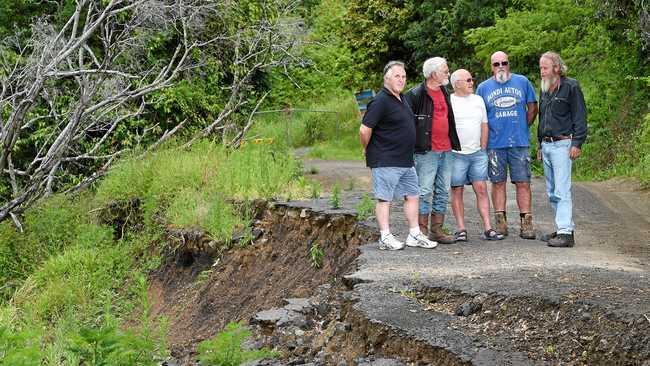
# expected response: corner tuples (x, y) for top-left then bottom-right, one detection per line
(414, 288), (650, 365)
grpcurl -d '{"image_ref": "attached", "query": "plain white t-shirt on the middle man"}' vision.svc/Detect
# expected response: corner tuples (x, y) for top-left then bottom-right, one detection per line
(451, 94), (487, 154)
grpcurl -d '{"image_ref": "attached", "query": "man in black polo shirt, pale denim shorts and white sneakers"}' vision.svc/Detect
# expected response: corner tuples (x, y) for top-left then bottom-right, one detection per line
(359, 61), (438, 250)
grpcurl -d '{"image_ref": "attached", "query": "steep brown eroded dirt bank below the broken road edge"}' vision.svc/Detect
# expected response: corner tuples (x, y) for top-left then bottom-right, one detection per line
(149, 204), (370, 358)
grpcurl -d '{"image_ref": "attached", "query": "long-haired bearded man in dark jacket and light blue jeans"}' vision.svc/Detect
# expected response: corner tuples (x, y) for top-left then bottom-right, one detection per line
(537, 52), (587, 247)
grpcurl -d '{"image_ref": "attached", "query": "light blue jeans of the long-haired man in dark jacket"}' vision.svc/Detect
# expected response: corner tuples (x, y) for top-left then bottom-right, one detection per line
(542, 140), (575, 234)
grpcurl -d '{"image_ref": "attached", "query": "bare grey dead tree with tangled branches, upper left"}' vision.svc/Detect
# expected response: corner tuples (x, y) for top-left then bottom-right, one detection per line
(0, 0), (298, 226)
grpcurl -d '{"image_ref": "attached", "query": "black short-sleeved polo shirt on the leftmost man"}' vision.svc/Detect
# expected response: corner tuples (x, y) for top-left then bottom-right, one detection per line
(362, 88), (415, 168)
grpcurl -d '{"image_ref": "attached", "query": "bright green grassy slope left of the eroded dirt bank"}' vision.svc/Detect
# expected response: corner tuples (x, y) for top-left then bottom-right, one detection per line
(0, 141), (306, 365)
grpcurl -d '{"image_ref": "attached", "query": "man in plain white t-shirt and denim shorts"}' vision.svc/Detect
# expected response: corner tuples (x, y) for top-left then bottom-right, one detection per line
(450, 69), (503, 241)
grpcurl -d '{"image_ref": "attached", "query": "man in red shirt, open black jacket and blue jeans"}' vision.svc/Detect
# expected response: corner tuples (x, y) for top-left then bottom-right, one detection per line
(406, 57), (460, 244)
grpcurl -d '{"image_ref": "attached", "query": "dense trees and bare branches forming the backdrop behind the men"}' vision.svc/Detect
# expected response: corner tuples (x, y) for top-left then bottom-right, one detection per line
(0, 0), (650, 219)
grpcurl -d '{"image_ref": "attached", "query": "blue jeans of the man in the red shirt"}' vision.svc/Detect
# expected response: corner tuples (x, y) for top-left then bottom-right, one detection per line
(415, 151), (454, 215)
